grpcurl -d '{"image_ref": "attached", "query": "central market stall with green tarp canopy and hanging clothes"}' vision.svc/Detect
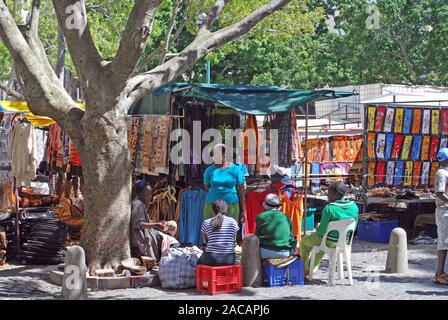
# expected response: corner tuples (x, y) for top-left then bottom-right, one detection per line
(128, 83), (352, 245)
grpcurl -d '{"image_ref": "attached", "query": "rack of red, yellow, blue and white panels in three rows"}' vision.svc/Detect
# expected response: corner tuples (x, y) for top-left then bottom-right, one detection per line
(367, 106), (448, 187)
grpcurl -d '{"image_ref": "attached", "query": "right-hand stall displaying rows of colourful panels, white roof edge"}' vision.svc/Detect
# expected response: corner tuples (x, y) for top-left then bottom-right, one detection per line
(359, 94), (448, 242)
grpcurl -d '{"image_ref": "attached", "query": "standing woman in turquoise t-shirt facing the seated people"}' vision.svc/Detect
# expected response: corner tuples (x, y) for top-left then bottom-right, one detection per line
(204, 144), (246, 223)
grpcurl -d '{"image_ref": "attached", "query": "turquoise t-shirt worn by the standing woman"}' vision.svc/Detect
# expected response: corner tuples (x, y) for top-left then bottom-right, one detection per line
(204, 163), (244, 204)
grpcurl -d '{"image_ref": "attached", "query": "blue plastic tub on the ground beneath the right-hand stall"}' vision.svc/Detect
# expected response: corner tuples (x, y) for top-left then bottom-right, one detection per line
(358, 220), (398, 243)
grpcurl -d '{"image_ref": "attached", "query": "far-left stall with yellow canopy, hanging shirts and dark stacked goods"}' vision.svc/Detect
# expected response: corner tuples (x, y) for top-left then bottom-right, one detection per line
(0, 101), (85, 264)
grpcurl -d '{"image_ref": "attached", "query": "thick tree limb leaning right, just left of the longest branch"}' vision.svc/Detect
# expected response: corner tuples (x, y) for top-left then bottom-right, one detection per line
(106, 0), (162, 93)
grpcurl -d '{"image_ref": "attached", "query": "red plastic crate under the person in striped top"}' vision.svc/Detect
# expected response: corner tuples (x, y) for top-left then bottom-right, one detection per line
(196, 265), (243, 295)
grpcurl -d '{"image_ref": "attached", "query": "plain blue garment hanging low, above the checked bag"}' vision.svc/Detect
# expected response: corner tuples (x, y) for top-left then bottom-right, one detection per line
(179, 189), (207, 245)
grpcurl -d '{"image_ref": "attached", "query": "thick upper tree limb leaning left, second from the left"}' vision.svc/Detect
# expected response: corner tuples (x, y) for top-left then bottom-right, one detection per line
(53, 0), (102, 92)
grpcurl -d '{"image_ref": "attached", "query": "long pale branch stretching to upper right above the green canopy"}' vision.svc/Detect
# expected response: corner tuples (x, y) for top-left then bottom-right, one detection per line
(122, 0), (292, 105)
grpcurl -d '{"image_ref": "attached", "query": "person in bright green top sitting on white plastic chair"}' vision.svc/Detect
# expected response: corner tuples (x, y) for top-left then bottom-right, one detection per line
(300, 181), (359, 276)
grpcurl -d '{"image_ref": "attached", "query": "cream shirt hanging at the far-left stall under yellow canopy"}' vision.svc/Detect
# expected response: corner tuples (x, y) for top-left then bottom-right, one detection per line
(9, 122), (38, 185)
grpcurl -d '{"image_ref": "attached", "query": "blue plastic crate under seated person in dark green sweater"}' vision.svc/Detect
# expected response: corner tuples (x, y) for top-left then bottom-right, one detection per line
(264, 259), (305, 287)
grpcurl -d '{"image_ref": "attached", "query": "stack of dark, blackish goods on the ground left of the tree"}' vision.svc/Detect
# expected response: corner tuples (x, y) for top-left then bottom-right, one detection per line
(22, 210), (68, 264)
